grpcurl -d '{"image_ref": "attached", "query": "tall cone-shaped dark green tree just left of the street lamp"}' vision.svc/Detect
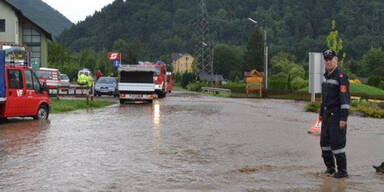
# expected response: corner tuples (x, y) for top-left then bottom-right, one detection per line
(243, 27), (264, 71)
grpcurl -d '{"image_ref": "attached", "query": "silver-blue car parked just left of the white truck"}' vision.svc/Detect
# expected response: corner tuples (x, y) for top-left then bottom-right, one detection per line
(95, 77), (119, 97)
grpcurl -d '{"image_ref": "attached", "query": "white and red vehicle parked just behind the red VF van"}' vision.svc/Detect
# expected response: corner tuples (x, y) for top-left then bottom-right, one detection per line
(36, 68), (60, 88)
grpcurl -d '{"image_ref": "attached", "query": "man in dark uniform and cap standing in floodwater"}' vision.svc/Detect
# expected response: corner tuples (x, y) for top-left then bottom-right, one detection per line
(319, 50), (350, 178)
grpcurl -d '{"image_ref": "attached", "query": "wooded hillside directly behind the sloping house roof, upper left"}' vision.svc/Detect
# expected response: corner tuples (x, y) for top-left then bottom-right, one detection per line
(7, 0), (73, 37)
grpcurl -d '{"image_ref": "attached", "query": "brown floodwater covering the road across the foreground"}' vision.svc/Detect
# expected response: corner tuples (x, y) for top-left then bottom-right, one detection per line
(0, 92), (384, 192)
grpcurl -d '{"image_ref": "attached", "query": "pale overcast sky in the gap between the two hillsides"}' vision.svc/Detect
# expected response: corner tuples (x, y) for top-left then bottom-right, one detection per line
(43, 0), (114, 23)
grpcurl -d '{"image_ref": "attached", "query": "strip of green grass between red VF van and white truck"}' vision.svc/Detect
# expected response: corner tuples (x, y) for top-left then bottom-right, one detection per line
(51, 98), (115, 113)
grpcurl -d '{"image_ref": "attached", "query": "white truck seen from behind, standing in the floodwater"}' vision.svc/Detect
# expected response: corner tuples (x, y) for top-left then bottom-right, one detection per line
(118, 65), (159, 104)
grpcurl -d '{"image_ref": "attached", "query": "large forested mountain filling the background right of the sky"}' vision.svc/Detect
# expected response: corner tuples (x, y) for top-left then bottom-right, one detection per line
(57, 0), (384, 61)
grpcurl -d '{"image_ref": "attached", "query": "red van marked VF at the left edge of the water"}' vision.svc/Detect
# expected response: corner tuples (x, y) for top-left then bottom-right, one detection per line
(0, 45), (51, 119)
